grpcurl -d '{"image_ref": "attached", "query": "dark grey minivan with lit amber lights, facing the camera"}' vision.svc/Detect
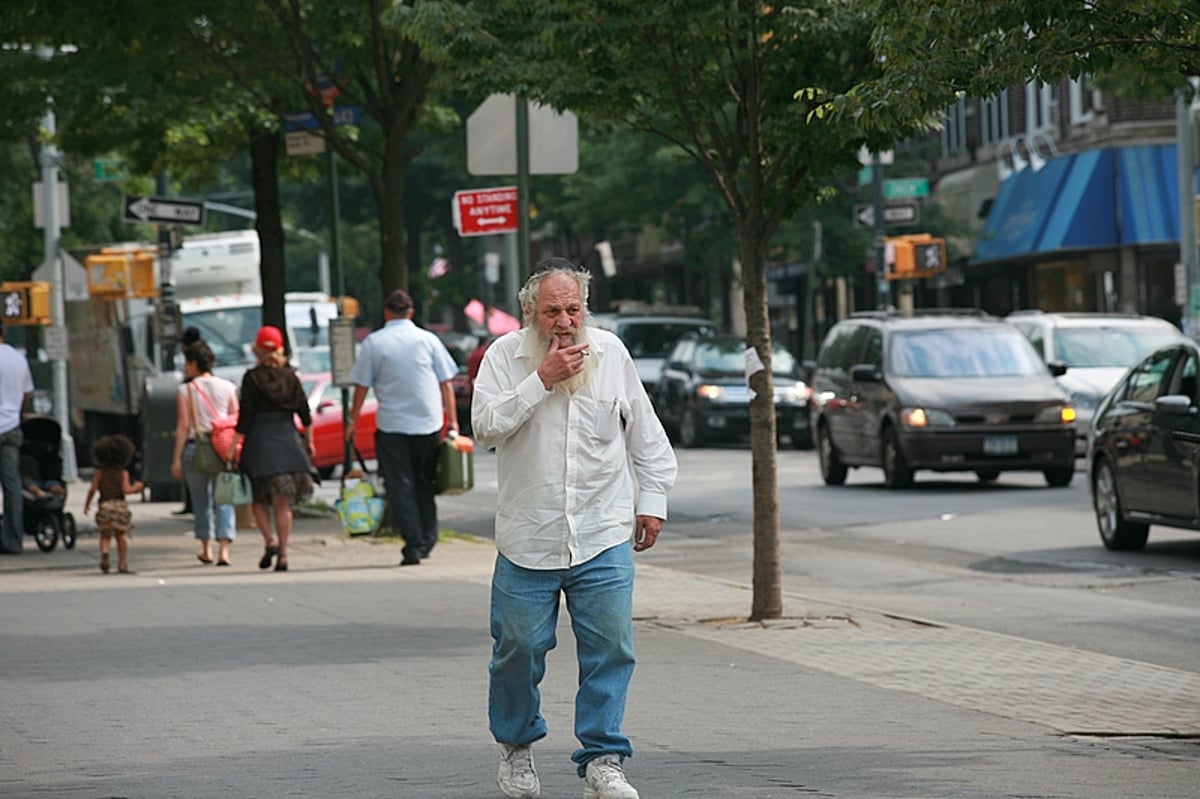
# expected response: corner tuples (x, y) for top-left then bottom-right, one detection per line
(811, 311), (1075, 488)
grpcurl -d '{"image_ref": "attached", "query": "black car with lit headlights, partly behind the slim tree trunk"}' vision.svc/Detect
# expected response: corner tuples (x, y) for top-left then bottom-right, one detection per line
(655, 334), (812, 449)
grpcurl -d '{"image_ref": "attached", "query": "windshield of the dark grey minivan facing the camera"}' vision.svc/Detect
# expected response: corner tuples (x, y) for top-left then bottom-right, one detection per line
(888, 328), (1045, 378)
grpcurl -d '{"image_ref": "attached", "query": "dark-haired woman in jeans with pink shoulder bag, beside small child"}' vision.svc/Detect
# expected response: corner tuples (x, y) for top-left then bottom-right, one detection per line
(170, 340), (238, 566)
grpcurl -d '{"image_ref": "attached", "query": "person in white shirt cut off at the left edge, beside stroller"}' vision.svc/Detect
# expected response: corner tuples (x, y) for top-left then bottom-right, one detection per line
(0, 324), (34, 554)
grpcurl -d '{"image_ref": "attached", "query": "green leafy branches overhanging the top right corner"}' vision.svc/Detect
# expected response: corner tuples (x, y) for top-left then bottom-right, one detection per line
(816, 0), (1200, 125)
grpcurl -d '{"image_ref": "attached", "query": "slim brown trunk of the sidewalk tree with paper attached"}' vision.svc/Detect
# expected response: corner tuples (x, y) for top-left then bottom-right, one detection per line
(738, 226), (784, 621)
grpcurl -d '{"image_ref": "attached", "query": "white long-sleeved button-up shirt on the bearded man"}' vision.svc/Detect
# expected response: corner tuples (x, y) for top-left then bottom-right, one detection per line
(470, 328), (677, 569)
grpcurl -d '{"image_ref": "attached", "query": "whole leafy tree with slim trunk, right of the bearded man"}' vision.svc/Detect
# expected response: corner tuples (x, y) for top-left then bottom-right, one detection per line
(422, 0), (894, 619)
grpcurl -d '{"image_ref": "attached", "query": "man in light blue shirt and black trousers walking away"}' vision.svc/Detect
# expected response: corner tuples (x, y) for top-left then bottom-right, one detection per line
(346, 289), (458, 566)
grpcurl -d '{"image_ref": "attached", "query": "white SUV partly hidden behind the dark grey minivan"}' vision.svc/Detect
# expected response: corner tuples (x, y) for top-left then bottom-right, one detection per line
(1006, 311), (1184, 456)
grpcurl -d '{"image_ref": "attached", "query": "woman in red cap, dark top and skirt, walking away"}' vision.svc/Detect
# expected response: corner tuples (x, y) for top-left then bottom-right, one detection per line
(234, 325), (313, 571)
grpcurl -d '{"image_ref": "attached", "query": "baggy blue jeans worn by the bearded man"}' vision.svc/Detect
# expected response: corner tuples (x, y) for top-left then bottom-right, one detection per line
(487, 542), (634, 776)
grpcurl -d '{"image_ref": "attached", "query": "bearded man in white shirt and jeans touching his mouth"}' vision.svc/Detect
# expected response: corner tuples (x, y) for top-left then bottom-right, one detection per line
(472, 258), (677, 799)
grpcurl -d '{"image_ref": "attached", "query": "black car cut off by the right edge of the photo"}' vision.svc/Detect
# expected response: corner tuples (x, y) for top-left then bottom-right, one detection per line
(1087, 338), (1200, 551)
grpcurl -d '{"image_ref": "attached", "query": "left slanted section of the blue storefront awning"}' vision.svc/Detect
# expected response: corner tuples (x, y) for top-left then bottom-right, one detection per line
(972, 150), (1118, 264)
